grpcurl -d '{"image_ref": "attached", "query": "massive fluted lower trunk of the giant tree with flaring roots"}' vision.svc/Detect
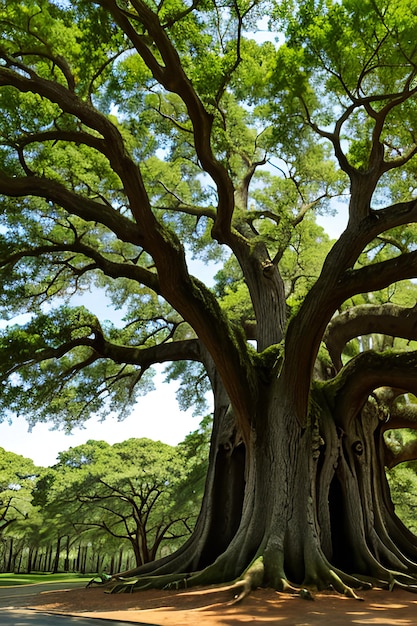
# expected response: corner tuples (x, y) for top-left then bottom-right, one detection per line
(106, 354), (417, 596)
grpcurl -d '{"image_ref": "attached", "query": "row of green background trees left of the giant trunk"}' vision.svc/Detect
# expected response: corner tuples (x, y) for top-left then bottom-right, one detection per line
(0, 418), (211, 573)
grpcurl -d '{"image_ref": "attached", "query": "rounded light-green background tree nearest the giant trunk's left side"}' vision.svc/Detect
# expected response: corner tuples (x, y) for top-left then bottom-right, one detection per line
(35, 439), (201, 571)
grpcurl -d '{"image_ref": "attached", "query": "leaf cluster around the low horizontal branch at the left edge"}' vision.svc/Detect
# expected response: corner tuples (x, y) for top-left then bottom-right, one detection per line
(0, 307), (152, 430)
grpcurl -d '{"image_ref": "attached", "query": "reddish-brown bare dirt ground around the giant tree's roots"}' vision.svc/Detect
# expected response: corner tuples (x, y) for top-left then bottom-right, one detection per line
(23, 588), (417, 626)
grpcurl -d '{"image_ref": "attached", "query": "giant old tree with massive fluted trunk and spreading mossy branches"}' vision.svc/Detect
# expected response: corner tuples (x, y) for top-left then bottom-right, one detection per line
(0, 0), (417, 593)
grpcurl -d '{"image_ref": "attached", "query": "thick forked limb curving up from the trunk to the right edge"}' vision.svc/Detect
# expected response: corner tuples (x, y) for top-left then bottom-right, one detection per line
(284, 200), (417, 415)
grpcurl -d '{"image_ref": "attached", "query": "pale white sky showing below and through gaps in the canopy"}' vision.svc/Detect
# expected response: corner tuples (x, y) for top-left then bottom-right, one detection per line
(0, 183), (346, 467)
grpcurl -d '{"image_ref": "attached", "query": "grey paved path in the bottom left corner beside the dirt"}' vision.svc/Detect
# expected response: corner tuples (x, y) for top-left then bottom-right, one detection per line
(0, 583), (157, 626)
